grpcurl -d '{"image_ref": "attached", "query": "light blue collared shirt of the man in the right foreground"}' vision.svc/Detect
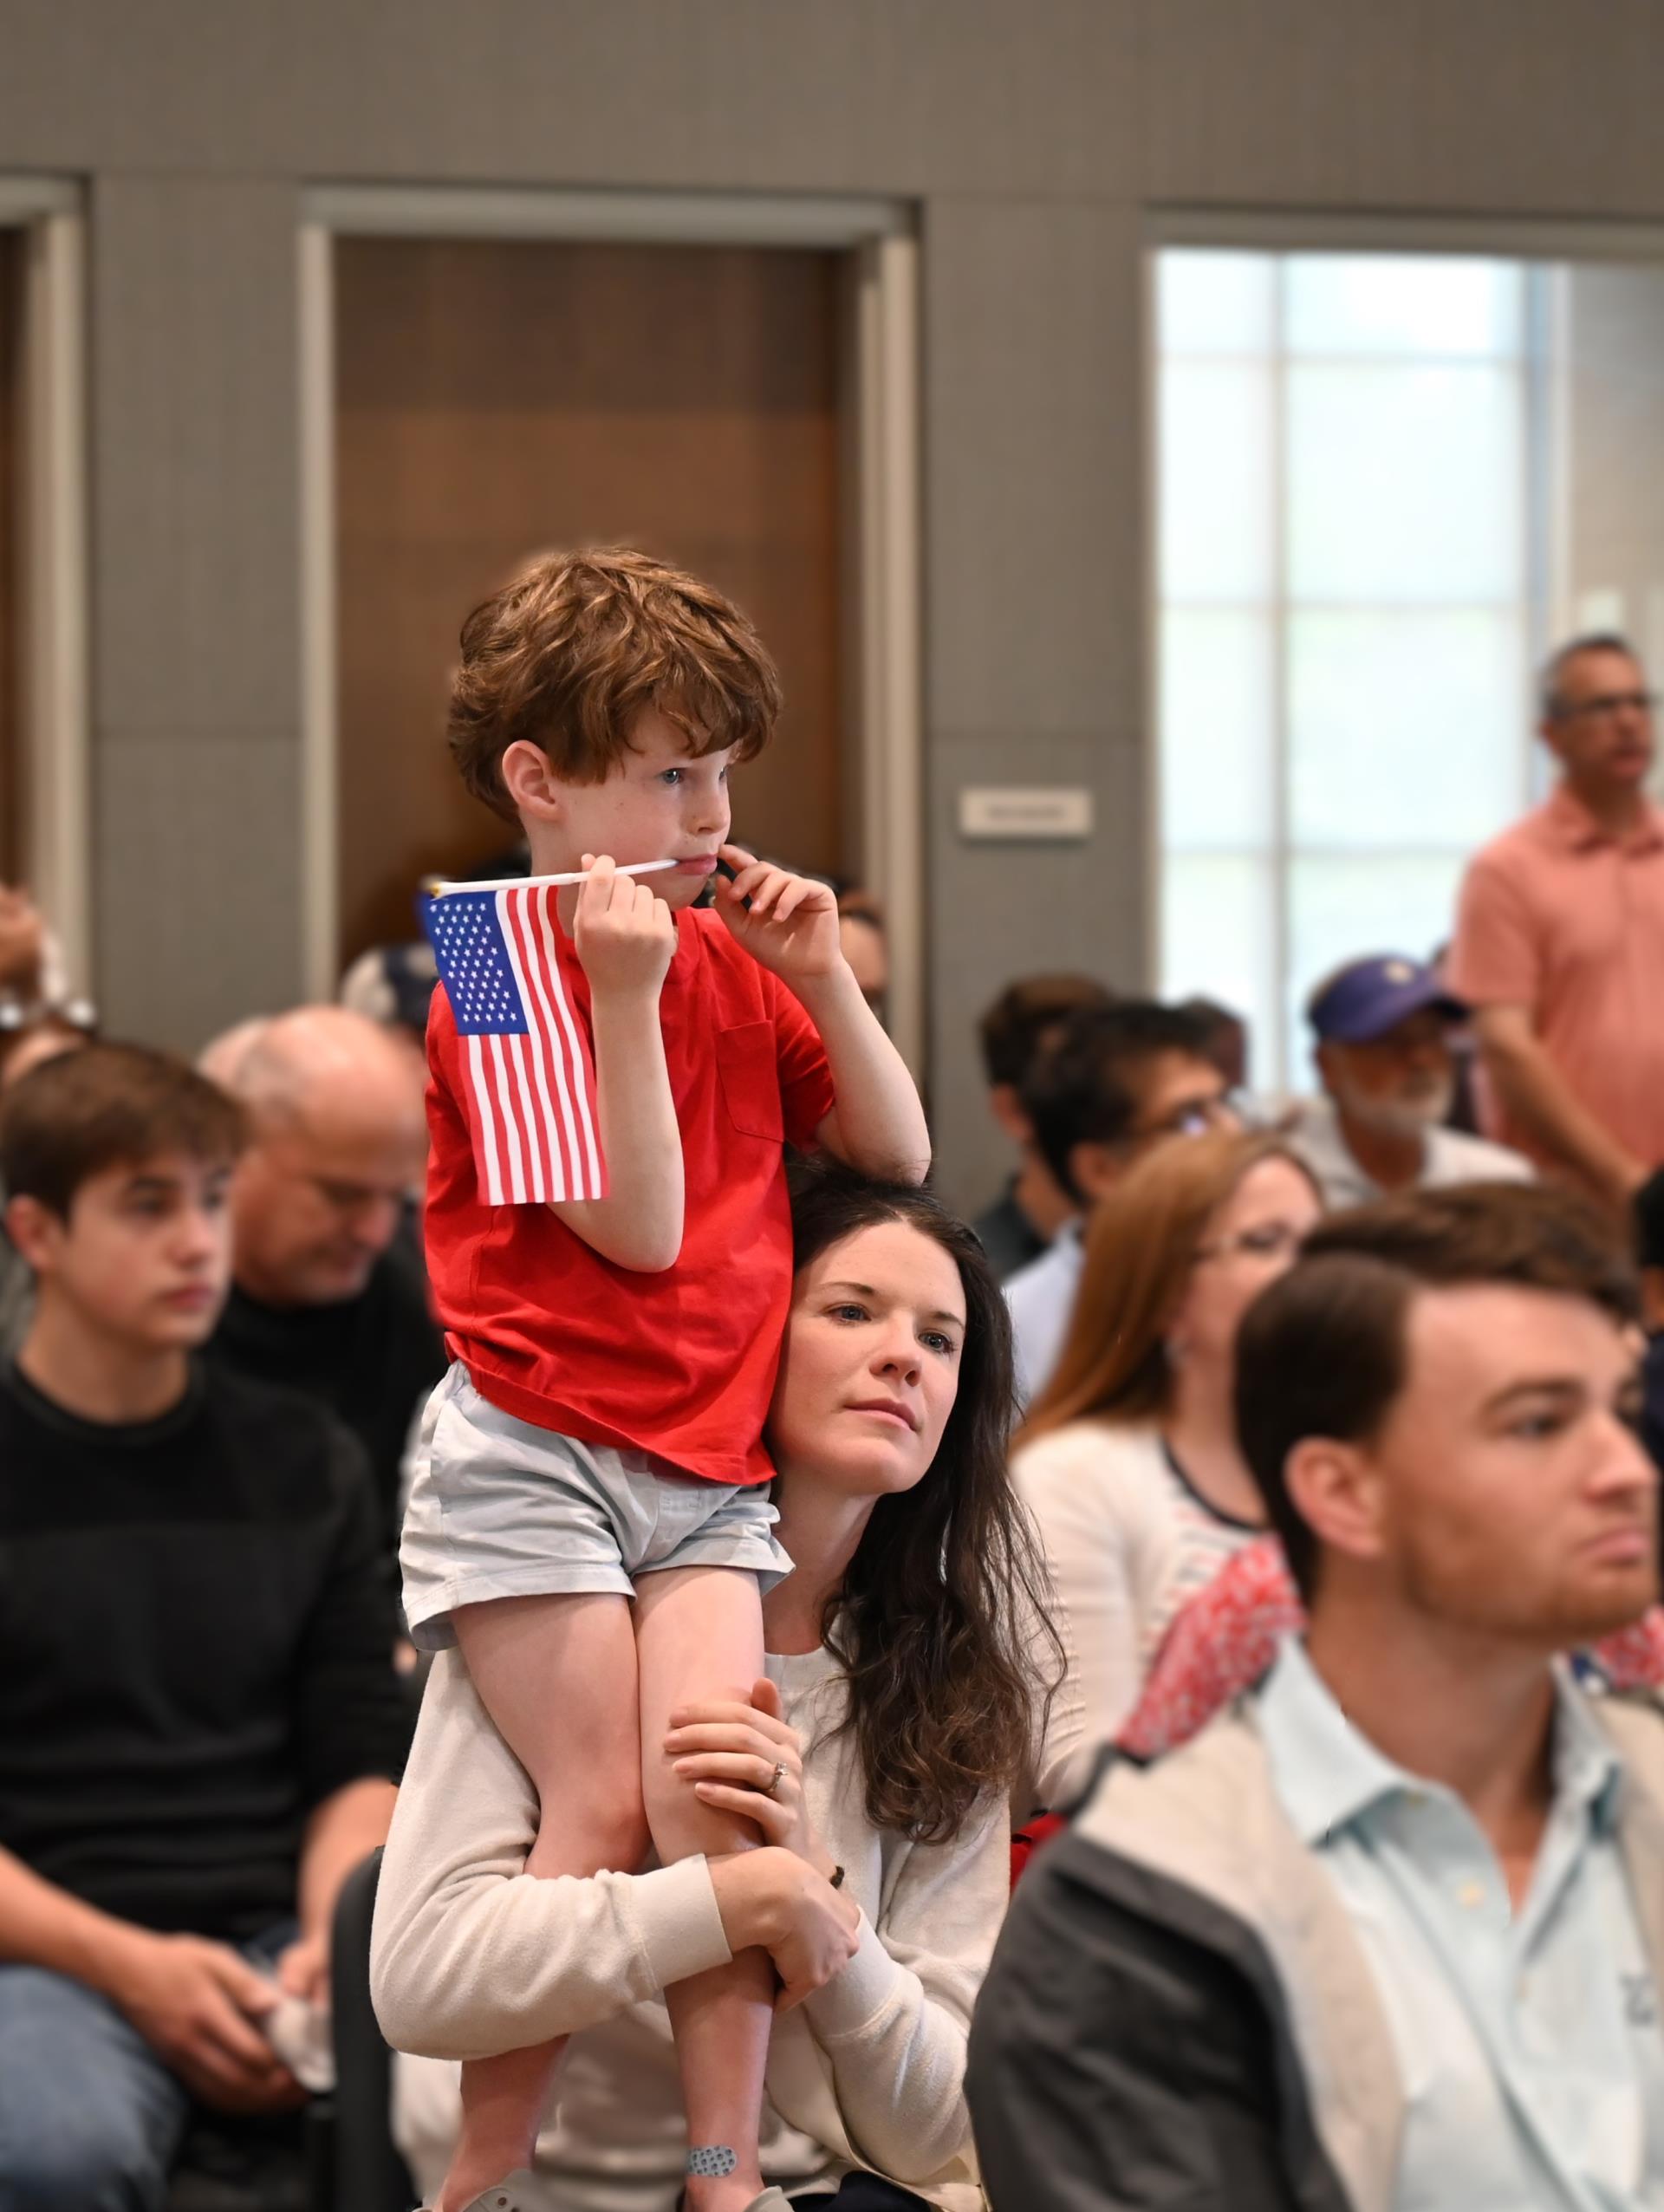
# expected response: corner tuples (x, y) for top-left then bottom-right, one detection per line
(1259, 1642), (1664, 2212)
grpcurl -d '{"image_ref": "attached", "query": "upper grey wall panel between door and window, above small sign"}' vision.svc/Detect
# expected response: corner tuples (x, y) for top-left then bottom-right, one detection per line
(925, 199), (1141, 732)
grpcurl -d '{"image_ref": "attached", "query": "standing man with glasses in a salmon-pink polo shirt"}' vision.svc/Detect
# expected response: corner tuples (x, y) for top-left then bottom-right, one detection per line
(1447, 634), (1664, 1210)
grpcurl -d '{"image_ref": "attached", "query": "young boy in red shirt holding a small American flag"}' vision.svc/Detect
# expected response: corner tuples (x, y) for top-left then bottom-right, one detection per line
(403, 553), (929, 2212)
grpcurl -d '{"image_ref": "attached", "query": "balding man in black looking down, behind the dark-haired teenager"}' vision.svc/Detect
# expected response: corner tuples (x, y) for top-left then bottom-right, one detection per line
(204, 1006), (445, 1546)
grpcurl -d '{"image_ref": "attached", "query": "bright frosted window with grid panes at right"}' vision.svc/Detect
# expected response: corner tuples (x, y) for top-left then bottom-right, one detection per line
(1157, 248), (1547, 1089)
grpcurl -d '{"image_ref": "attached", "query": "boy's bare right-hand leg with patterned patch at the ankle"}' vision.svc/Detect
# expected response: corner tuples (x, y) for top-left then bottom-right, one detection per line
(635, 1566), (775, 2212)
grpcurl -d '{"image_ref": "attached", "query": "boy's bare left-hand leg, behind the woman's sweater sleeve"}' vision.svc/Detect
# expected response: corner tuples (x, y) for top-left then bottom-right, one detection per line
(436, 1592), (648, 2212)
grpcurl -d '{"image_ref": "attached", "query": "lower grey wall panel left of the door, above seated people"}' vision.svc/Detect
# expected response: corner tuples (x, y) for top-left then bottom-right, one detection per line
(93, 730), (301, 1051)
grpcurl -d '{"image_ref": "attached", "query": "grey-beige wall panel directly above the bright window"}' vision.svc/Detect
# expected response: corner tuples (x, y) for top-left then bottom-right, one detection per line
(1141, 0), (1664, 215)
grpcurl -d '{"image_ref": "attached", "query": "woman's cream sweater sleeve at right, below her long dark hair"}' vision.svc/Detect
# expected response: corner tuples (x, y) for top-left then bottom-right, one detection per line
(805, 1800), (1011, 2183)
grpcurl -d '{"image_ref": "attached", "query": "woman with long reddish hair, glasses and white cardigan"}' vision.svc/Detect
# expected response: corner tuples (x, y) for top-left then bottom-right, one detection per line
(1011, 1130), (1321, 1746)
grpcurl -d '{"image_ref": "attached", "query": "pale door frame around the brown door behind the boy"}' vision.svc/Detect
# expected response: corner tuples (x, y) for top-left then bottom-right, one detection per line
(299, 185), (925, 1075)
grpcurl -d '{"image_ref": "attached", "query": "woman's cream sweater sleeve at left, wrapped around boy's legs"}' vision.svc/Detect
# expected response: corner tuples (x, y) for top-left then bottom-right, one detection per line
(369, 1652), (732, 2059)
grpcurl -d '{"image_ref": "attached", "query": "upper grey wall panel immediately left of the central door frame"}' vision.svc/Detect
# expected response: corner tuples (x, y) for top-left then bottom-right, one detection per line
(93, 177), (299, 734)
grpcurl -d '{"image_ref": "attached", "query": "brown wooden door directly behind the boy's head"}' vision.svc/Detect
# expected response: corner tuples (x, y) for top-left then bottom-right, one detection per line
(336, 239), (848, 965)
